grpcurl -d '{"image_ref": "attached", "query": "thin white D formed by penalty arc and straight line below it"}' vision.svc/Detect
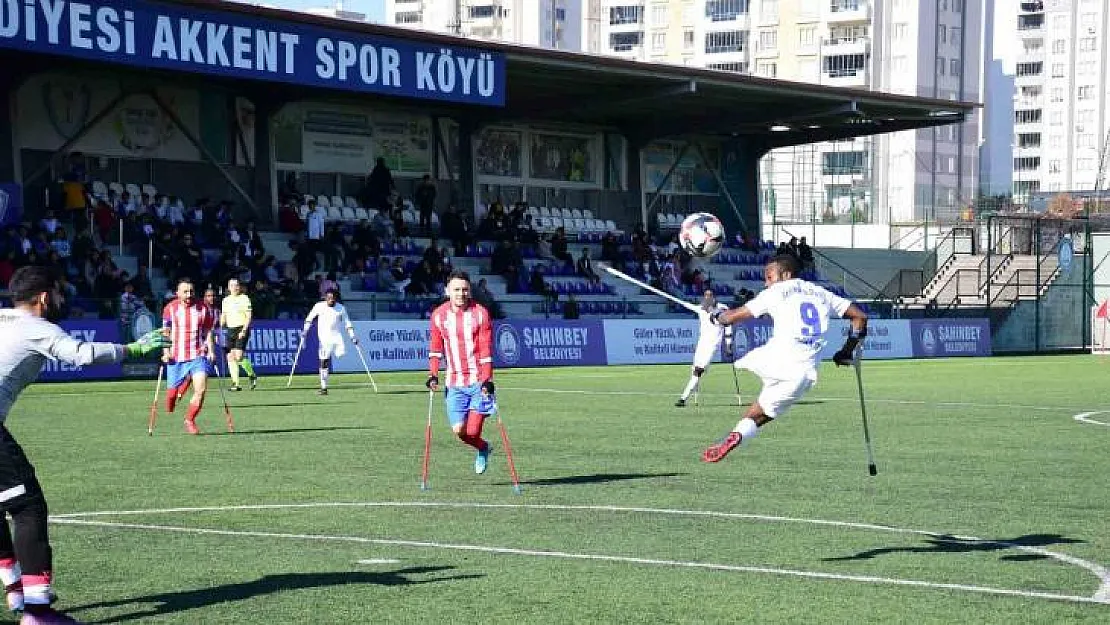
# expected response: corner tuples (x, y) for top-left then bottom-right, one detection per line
(51, 502), (1110, 604)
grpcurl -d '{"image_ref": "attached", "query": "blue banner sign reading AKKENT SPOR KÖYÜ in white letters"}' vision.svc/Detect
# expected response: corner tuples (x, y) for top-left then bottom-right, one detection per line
(0, 0), (505, 107)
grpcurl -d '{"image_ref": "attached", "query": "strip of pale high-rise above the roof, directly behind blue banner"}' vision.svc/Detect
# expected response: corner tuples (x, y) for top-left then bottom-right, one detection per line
(385, 0), (584, 50)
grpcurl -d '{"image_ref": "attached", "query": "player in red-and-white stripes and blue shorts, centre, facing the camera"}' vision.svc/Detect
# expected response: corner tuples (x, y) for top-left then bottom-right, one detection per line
(426, 271), (496, 473)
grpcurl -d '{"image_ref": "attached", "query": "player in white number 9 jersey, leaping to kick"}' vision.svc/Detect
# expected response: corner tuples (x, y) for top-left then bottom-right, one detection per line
(702, 255), (867, 462)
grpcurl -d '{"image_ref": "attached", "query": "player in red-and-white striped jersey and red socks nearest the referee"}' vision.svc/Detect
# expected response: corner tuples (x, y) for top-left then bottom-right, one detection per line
(162, 279), (218, 434)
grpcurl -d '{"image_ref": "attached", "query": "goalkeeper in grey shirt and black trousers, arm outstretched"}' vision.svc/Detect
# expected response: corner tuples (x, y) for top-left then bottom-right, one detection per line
(0, 266), (170, 625)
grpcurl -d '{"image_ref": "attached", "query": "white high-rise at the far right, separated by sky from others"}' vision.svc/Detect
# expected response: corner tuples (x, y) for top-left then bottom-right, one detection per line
(1013, 0), (1110, 202)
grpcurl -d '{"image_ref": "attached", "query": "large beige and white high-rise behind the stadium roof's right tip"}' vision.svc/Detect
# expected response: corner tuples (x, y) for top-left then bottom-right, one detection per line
(585, 0), (982, 223)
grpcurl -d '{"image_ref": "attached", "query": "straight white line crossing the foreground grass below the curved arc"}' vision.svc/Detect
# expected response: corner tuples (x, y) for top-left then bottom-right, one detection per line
(51, 518), (1110, 605)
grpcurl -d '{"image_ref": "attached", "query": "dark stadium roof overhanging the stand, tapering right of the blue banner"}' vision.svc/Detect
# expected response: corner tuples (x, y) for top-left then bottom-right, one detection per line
(32, 0), (978, 148)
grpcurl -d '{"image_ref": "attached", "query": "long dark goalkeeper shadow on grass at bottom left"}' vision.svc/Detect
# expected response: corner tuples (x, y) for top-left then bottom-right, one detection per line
(70, 566), (484, 624)
